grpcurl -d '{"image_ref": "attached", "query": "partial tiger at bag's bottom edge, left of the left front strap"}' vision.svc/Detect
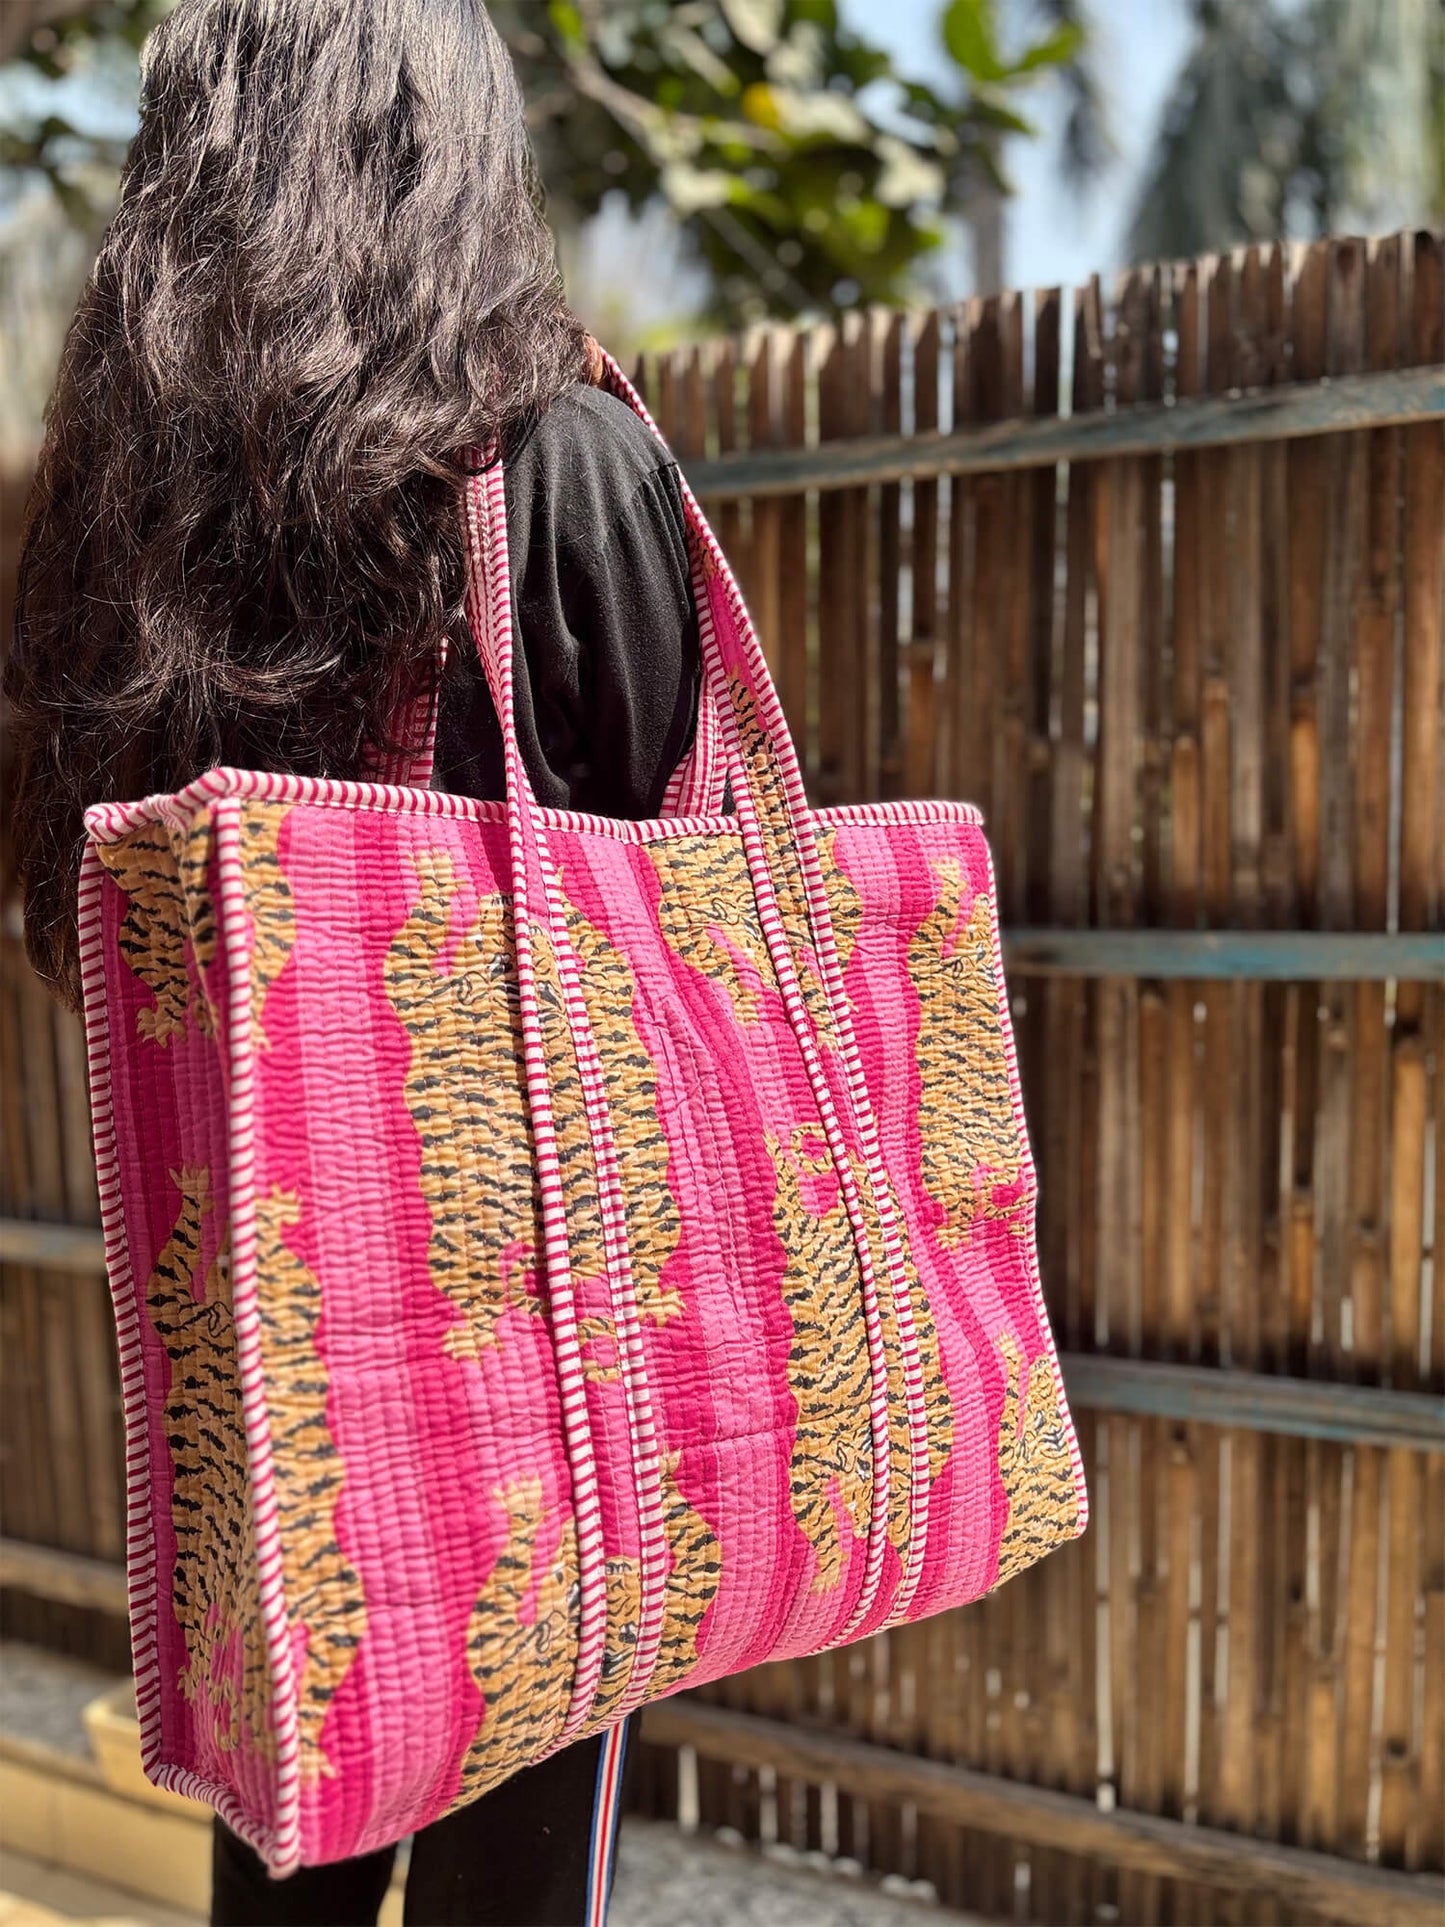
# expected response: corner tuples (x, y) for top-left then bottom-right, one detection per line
(455, 1474), (580, 1806)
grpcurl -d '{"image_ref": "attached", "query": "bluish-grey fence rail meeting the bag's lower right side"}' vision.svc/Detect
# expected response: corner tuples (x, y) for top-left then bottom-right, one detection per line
(1060, 1351), (1445, 1451)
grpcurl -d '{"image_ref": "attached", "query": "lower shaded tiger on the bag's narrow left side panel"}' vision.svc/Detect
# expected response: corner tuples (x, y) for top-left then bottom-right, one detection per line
(146, 1166), (272, 1754)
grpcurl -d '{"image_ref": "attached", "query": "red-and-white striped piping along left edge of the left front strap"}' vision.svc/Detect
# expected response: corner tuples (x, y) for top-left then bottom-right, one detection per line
(466, 462), (607, 1740)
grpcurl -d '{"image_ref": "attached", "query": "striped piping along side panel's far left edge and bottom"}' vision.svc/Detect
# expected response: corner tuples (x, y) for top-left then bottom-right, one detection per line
(79, 848), (290, 1856)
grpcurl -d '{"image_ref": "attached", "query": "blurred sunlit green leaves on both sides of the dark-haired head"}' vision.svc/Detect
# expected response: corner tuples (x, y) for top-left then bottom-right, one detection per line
(0, 0), (1087, 322)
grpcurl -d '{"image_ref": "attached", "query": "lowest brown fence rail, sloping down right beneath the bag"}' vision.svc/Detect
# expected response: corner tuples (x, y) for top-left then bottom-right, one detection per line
(642, 1696), (1445, 1927)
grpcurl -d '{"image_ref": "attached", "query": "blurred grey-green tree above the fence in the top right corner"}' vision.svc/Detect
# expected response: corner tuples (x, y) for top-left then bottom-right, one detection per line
(1129, 0), (1445, 260)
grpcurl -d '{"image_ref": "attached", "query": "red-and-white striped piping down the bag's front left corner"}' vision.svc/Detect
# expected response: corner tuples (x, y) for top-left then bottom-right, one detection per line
(212, 798), (301, 1875)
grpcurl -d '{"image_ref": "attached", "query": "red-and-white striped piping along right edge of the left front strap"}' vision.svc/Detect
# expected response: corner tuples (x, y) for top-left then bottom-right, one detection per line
(541, 854), (670, 1719)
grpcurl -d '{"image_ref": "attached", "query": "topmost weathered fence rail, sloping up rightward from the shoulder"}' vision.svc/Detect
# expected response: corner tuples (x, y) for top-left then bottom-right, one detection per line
(684, 368), (1445, 501)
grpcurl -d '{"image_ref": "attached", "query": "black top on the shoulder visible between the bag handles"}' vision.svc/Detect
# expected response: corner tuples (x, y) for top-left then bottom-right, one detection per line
(432, 387), (699, 817)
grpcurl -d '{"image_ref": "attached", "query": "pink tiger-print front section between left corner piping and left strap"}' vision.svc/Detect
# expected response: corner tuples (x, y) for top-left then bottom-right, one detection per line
(241, 802), (597, 1863)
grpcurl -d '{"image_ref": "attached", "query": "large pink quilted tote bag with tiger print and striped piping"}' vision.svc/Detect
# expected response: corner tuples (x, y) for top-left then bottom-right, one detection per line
(81, 350), (1085, 1873)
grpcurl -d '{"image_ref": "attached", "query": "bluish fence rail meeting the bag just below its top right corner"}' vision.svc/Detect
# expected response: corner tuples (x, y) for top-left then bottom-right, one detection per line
(1004, 929), (1445, 983)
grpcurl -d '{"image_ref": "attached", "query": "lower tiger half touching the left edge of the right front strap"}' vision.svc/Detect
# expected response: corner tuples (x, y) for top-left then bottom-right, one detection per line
(767, 1125), (873, 1594)
